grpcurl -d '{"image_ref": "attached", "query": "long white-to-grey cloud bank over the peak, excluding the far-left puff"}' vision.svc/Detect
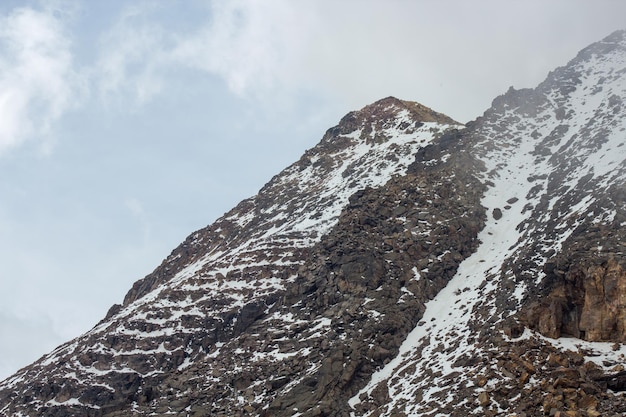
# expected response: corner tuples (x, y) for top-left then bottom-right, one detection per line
(89, 0), (626, 121)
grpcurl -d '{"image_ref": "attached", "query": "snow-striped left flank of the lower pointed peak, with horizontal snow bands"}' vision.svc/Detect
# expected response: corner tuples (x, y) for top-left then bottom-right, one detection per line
(0, 94), (464, 415)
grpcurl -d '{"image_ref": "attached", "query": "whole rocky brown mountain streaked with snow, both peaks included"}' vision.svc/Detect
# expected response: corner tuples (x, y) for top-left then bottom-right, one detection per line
(0, 31), (626, 417)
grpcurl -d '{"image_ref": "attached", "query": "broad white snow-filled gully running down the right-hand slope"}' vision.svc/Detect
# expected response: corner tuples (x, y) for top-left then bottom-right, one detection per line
(348, 67), (624, 410)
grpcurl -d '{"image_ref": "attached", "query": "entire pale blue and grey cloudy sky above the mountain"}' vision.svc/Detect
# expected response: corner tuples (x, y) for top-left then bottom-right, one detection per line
(0, 0), (626, 379)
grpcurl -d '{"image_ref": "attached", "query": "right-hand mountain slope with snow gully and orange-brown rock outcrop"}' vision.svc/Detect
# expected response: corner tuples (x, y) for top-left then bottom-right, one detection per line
(350, 32), (626, 416)
